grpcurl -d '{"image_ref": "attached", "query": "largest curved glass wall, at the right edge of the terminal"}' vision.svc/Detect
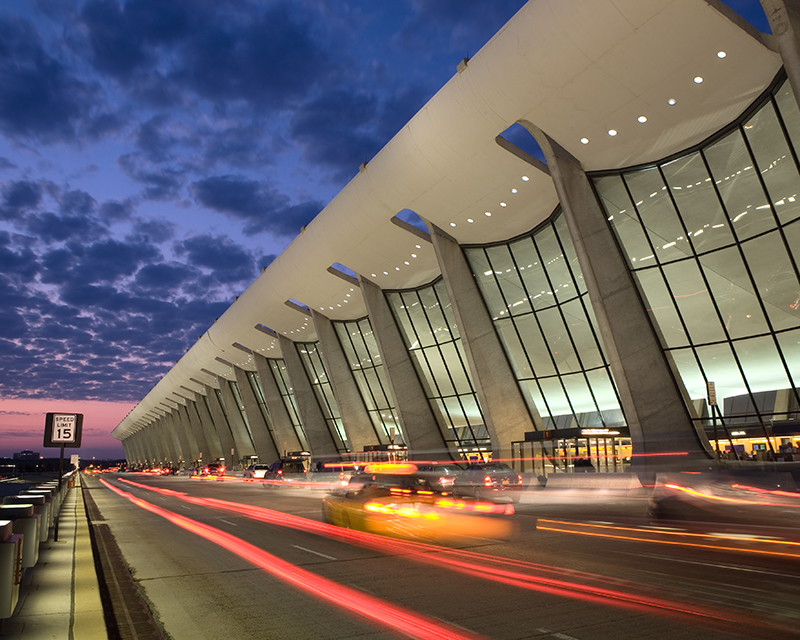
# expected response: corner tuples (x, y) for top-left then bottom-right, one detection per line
(593, 74), (800, 455)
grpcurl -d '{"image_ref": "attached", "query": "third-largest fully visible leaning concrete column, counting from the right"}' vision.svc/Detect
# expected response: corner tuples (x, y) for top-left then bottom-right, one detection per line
(358, 276), (447, 460)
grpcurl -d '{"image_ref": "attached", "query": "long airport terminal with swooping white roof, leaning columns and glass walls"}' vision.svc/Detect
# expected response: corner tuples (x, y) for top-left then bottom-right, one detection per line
(113, 0), (800, 475)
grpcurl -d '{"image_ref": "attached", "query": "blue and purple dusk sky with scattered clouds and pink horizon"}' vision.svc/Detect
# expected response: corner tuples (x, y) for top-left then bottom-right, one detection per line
(0, 0), (768, 459)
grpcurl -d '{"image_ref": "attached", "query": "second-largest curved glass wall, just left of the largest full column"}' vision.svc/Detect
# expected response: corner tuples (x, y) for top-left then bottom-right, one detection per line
(465, 212), (625, 429)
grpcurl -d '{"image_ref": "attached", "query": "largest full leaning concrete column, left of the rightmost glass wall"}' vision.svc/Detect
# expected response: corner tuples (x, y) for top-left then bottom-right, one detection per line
(520, 120), (710, 469)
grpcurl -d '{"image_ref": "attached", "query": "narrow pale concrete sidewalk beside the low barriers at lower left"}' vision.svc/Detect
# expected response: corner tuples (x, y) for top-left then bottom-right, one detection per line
(0, 474), (108, 640)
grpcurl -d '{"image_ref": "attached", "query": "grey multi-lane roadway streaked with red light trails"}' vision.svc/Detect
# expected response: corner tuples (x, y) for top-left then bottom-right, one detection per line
(85, 473), (800, 640)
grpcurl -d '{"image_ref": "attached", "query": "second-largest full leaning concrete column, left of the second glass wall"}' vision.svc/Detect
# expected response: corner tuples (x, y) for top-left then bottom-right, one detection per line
(426, 222), (544, 459)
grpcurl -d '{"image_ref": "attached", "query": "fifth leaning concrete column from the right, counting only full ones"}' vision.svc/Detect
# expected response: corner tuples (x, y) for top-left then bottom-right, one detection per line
(278, 335), (339, 462)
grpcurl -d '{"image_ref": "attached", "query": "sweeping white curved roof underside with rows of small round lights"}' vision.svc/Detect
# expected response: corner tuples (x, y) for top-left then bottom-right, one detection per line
(113, 0), (781, 439)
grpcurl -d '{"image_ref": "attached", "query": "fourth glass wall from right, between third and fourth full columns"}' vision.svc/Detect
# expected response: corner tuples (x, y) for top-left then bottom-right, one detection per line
(333, 318), (405, 444)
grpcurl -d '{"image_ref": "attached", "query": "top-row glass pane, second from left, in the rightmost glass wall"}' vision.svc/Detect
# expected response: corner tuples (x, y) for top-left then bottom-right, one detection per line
(624, 169), (692, 262)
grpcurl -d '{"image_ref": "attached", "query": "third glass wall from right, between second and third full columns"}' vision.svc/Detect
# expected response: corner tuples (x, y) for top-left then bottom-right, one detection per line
(386, 279), (491, 455)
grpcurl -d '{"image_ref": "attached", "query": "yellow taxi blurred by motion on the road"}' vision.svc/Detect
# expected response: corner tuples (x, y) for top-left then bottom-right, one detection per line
(322, 463), (515, 542)
